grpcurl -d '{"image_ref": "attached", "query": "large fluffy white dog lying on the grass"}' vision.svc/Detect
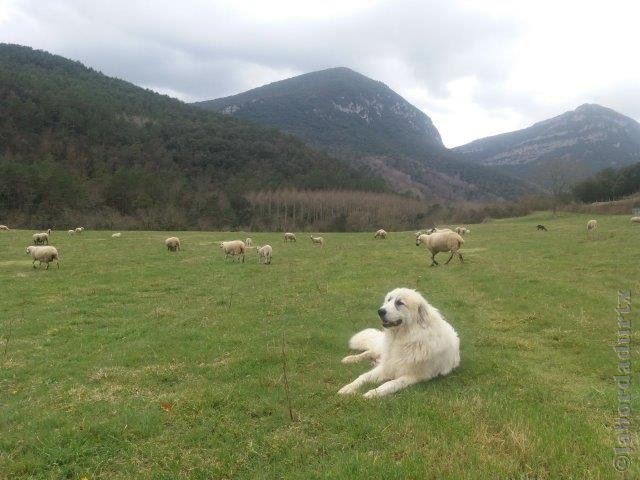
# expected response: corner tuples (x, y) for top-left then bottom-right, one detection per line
(338, 288), (460, 398)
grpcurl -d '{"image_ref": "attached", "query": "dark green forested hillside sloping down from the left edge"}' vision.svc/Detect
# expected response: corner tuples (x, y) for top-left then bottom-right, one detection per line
(0, 44), (382, 228)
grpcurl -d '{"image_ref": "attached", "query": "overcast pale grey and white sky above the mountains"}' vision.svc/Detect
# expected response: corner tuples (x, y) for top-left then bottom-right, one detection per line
(0, 0), (640, 147)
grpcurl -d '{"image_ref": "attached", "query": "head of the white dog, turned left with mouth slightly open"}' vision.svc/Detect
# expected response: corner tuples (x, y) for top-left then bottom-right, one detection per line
(378, 288), (429, 328)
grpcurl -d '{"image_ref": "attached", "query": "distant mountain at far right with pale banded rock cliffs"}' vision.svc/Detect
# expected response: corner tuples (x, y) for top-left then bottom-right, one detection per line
(453, 104), (640, 179)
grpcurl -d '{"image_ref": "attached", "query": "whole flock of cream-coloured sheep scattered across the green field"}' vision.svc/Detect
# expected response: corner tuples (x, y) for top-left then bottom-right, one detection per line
(0, 217), (640, 269)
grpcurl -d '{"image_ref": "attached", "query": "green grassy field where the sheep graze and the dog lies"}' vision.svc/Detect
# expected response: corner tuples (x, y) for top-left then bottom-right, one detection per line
(0, 213), (640, 480)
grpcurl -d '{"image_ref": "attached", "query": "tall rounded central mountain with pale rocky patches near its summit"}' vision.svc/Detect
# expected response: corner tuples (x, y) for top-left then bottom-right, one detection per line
(195, 68), (527, 199)
